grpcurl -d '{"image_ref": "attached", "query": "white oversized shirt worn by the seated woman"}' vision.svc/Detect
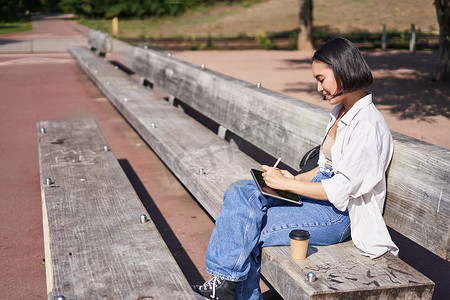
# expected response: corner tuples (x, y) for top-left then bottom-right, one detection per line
(319, 94), (398, 258)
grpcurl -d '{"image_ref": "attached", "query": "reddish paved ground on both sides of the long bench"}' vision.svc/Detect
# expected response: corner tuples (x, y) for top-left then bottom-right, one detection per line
(0, 14), (450, 299)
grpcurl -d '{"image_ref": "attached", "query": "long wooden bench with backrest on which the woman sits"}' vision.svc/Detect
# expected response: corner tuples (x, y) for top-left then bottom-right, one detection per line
(69, 47), (450, 299)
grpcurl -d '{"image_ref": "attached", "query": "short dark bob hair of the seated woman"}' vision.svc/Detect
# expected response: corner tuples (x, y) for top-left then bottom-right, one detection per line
(312, 38), (373, 96)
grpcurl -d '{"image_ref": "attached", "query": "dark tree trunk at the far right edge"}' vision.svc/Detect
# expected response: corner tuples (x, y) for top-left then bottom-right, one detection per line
(434, 0), (450, 81)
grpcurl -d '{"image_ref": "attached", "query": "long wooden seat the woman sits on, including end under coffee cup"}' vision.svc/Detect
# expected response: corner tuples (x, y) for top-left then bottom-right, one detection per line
(70, 45), (434, 299)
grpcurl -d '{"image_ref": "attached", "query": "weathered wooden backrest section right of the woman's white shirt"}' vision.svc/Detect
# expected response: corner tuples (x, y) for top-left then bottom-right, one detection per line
(384, 132), (450, 260)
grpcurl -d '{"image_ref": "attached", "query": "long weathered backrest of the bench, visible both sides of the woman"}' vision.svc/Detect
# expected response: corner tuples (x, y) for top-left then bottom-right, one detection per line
(133, 48), (450, 259)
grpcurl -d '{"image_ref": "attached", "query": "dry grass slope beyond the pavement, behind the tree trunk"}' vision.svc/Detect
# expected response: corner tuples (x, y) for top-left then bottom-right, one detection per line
(80, 0), (439, 39)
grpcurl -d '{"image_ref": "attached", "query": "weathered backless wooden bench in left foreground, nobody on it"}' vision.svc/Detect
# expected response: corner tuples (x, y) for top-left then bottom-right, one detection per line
(38, 118), (196, 300)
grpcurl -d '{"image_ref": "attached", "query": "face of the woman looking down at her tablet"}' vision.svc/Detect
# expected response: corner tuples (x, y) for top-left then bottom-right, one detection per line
(312, 61), (342, 105)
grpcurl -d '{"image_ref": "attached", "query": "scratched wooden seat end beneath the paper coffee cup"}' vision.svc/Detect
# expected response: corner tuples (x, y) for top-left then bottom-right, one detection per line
(262, 241), (434, 299)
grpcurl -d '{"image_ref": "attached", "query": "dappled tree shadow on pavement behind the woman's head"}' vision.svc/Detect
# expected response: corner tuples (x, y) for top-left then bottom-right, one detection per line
(283, 51), (450, 122)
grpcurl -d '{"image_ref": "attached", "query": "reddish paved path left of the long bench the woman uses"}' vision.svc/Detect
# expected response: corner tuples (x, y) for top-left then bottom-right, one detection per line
(0, 15), (223, 299)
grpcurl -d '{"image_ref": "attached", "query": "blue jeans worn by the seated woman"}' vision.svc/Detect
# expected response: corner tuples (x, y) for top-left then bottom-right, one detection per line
(205, 171), (350, 300)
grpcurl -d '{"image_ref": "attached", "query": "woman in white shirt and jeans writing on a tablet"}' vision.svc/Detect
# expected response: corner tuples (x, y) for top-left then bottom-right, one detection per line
(193, 38), (398, 300)
